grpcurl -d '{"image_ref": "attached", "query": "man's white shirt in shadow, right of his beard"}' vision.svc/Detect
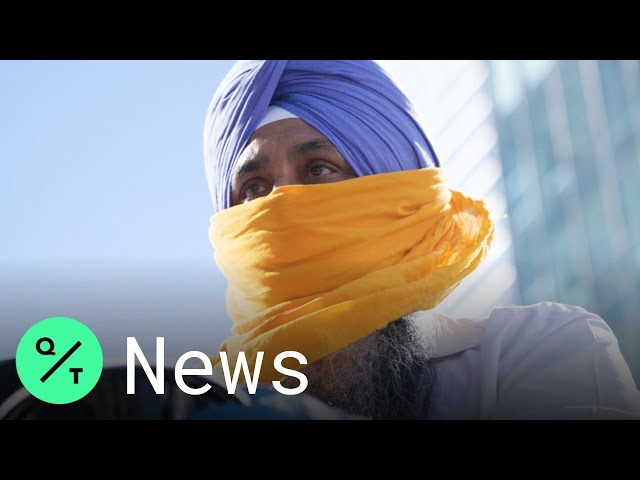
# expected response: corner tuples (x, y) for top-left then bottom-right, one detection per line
(430, 303), (640, 419)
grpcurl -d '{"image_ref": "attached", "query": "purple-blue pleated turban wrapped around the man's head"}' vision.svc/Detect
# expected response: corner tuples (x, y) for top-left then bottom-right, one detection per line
(204, 60), (440, 211)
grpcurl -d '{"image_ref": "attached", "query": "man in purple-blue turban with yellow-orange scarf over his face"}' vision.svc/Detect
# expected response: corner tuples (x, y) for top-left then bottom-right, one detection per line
(204, 61), (640, 419)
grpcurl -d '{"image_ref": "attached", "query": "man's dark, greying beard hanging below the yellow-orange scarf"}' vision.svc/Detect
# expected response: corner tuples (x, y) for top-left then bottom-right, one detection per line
(292, 312), (436, 420)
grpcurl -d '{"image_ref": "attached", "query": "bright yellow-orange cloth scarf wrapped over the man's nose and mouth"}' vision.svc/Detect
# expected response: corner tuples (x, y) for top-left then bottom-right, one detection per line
(209, 168), (494, 382)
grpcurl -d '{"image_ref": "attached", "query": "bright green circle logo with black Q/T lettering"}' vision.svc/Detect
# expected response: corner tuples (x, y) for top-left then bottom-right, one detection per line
(16, 317), (102, 404)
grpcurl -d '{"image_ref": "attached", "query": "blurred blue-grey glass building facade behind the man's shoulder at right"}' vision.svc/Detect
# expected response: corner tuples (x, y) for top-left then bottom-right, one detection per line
(489, 60), (640, 382)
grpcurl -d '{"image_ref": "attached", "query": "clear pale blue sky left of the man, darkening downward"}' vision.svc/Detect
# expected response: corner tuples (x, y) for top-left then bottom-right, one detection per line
(0, 61), (238, 359)
